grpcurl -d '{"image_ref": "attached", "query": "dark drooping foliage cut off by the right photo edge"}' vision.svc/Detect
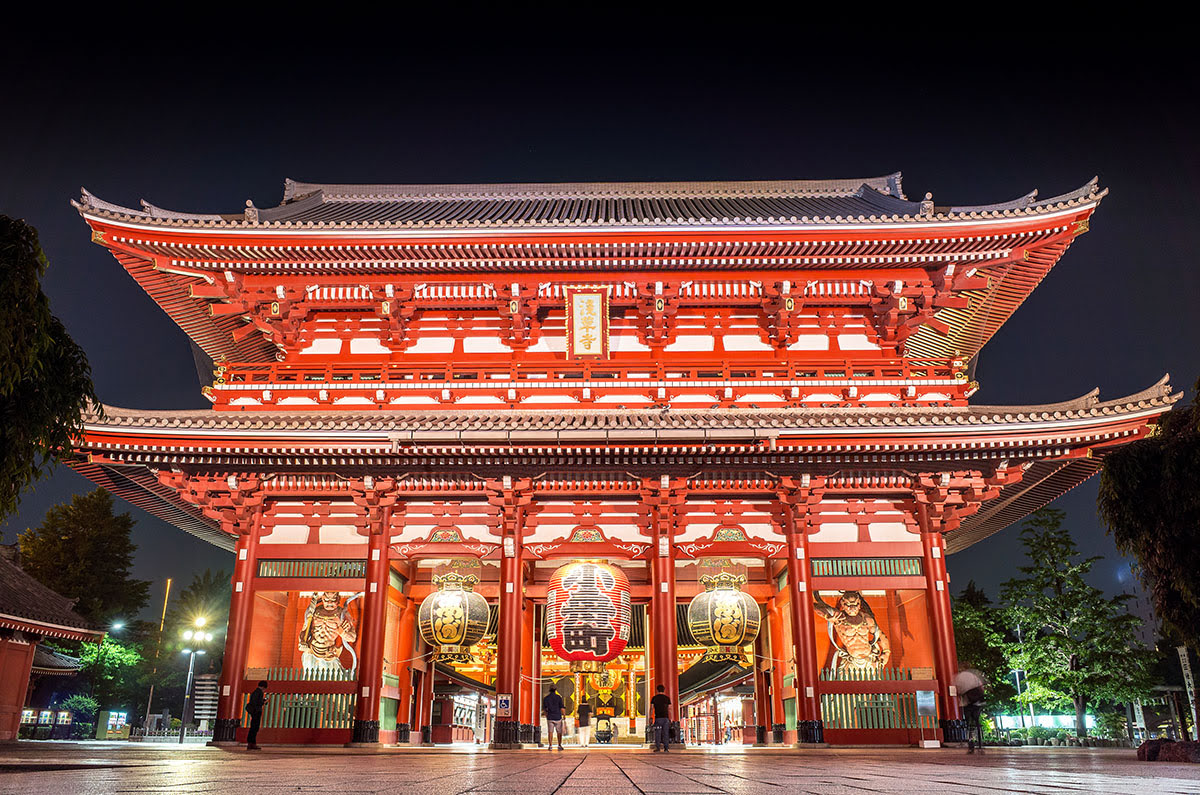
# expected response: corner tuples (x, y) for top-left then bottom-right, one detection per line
(1098, 381), (1200, 653)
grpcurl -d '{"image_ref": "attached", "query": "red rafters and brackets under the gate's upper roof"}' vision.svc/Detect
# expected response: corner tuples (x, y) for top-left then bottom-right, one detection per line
(85, 203), (1096, 361)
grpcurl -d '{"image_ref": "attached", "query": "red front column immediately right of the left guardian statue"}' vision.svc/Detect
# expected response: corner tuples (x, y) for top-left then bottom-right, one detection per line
(350, 516), (391, 743)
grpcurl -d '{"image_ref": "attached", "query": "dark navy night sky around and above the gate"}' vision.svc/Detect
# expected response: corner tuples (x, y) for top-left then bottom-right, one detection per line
(0, 26), (1200, 624)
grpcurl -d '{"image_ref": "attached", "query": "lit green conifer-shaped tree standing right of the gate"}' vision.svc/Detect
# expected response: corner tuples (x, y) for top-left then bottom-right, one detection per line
(1001, 508), (1151, 737)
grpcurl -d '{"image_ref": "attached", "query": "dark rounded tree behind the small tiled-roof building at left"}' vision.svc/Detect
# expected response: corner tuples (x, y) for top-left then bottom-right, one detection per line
(18, 489), (150, 624)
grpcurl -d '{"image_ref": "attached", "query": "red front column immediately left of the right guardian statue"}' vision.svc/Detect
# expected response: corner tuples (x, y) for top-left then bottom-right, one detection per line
(785, 516), (823, 742)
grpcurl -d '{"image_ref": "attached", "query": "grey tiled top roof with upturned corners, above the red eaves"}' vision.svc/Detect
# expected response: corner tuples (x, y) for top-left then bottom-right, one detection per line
(74, 172), (1105, 229)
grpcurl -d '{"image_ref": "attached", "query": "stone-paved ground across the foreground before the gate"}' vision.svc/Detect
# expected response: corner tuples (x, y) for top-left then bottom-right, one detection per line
(0, 742), (1200, 795)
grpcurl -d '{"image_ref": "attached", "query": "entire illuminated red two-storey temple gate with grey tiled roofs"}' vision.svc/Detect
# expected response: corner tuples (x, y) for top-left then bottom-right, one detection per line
(65, 174), (1176, 746)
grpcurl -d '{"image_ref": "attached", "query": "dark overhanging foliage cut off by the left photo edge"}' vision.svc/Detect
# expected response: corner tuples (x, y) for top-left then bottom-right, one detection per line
(0, 215), (100, 518)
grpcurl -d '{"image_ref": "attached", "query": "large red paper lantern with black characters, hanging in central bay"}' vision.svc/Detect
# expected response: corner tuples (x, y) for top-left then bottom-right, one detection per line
(546, 561), (631, 673)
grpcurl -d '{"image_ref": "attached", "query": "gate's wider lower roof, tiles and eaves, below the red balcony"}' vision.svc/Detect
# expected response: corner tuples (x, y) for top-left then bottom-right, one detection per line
(63, 377), (1181, 552)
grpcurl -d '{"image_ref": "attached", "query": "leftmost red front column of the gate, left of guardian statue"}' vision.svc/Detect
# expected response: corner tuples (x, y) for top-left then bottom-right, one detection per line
(212, 507), (262, 743)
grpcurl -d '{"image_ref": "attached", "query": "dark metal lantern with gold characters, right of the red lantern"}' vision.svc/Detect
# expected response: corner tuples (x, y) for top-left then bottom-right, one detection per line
(688, 572), (762, 665)
